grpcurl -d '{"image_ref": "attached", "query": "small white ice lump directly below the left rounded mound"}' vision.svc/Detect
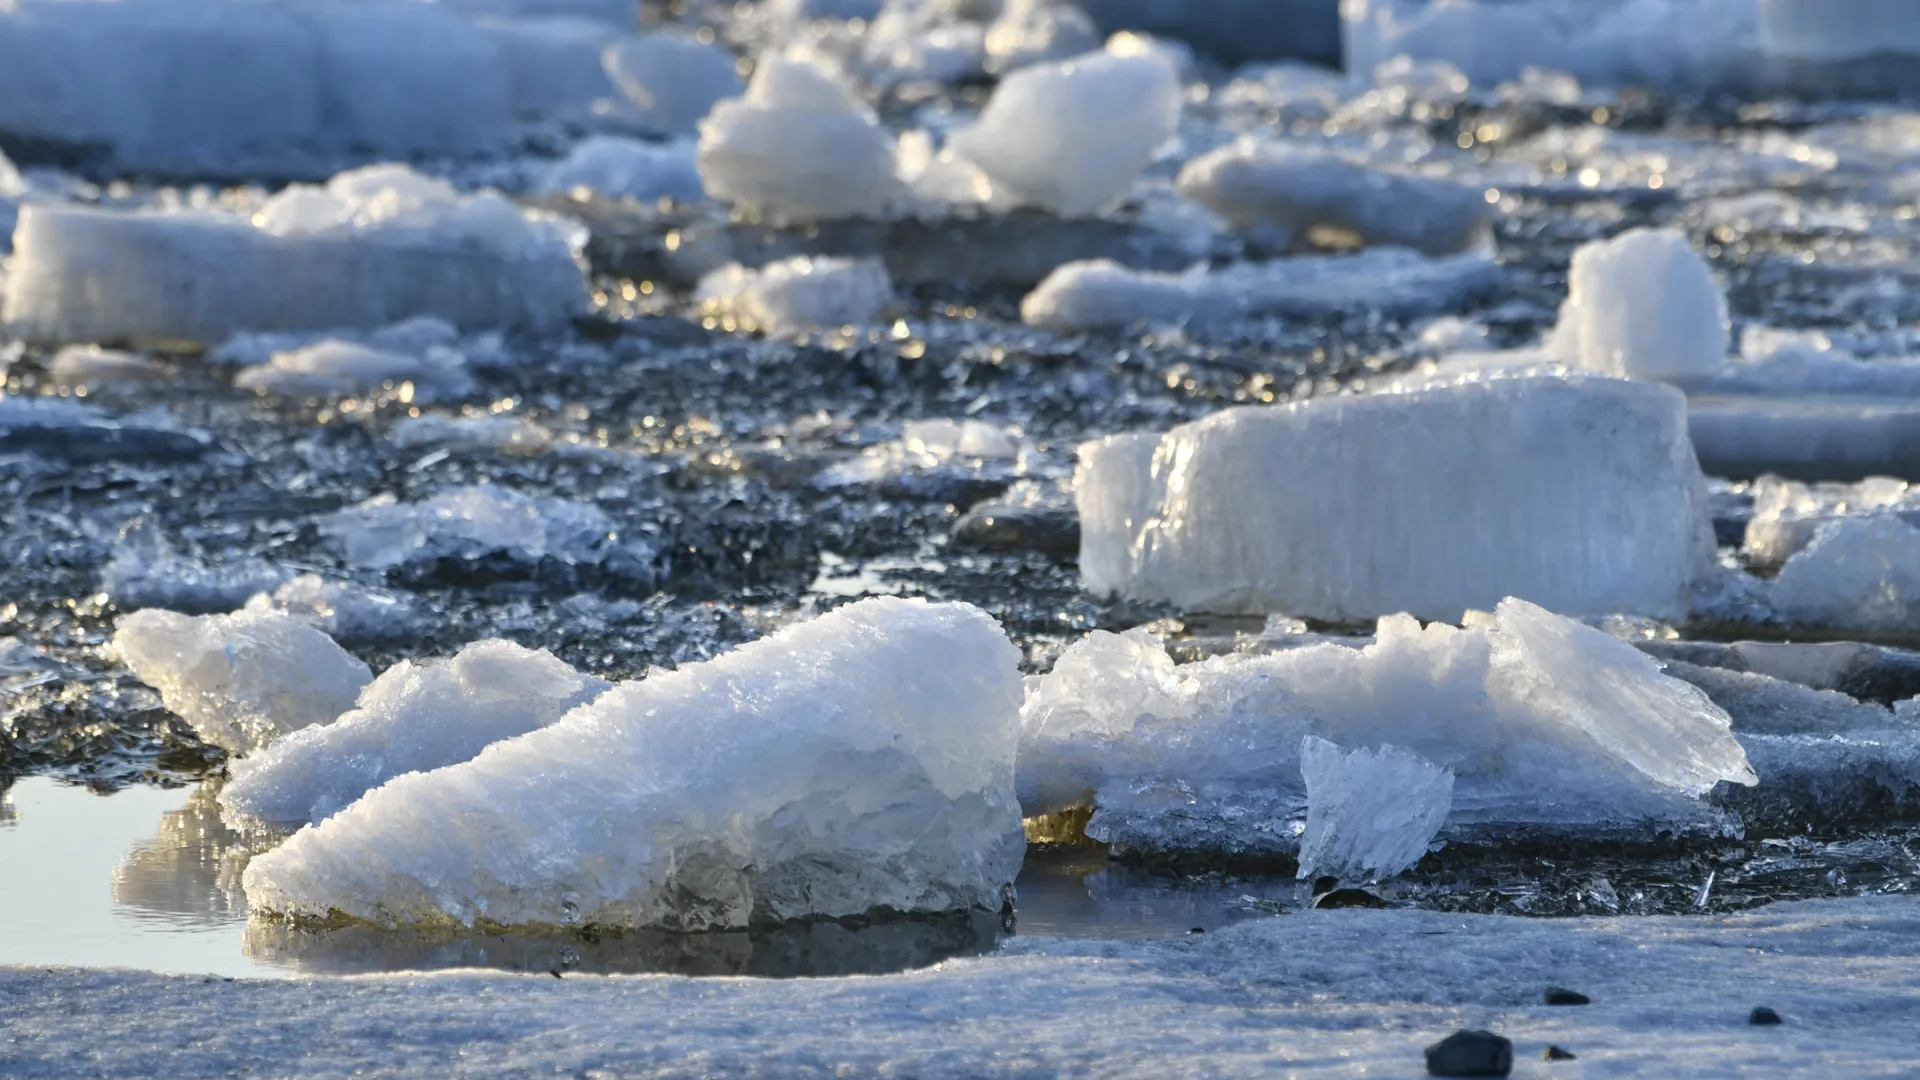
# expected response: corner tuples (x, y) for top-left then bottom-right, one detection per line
(695, 256), (893, 338)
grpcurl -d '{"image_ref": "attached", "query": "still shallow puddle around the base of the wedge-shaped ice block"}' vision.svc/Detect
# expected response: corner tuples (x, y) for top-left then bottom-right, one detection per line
(0, 776), (1298, 978)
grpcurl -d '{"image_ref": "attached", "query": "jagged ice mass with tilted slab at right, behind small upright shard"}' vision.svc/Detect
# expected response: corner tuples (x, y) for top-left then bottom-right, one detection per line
(1020, 600), (1755, 853)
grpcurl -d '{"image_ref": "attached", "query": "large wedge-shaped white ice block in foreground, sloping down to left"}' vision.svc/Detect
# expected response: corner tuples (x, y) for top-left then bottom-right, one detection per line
(246, 598), (1025, 930)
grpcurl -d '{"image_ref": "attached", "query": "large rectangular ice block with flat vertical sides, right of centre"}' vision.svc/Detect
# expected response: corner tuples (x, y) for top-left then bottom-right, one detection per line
(1075, 377), (1713, 623)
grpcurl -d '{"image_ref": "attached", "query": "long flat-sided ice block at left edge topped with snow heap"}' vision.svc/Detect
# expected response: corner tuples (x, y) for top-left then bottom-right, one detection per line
(0, 168), (586, 348)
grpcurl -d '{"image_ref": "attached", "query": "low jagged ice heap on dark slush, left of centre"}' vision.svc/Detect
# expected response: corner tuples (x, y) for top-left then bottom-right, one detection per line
(321, 484), (616, 571)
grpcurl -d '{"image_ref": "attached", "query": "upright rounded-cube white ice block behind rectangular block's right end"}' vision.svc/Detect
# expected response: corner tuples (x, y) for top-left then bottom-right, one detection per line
(1549, 229), (1730, 379)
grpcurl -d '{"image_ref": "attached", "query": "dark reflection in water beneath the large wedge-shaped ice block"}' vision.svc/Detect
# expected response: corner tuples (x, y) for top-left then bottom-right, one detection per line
(244, 911), (1002, 978)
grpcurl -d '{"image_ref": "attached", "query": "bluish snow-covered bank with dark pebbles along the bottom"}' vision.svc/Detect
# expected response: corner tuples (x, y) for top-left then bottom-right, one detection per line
(0, 897), (1920, 1080)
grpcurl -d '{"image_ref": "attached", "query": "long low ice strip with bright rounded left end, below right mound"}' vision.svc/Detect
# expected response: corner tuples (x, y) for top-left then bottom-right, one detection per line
(1020, 248), (1501, 332)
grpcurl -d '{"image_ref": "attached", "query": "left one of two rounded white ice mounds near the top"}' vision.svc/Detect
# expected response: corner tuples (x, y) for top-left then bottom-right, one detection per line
(699, 56), (908, 225)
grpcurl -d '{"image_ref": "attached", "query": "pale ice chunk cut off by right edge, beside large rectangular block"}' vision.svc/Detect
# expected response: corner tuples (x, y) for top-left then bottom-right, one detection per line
(1772, 513), (1920, 630)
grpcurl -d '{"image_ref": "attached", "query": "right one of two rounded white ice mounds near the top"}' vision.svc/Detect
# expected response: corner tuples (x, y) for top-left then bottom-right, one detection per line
(948, 52), (1181, 217)
